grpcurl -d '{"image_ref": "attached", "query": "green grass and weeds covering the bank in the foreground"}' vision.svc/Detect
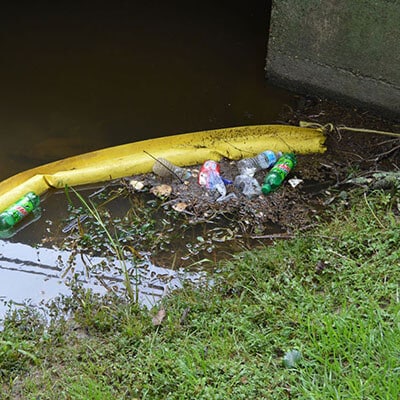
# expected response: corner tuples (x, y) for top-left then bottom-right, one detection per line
(0, 192), (400, 400)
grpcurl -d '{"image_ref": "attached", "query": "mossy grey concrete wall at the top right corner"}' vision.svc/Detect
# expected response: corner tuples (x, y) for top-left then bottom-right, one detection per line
(266, 0), (400, 116)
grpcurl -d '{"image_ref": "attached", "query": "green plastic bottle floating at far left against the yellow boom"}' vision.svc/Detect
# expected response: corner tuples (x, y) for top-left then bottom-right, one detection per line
(0, 192), (40, 237)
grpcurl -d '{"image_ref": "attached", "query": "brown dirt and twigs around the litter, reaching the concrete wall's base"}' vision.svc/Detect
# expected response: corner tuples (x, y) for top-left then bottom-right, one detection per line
(124, 97), (400, 238)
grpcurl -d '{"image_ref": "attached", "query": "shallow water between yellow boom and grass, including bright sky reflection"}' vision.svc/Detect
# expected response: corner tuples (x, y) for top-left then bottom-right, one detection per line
(0, 186), (208, 320)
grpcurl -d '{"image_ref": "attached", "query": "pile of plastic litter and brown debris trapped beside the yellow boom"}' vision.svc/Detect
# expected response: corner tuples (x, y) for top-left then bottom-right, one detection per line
(122, 151), (319, 237)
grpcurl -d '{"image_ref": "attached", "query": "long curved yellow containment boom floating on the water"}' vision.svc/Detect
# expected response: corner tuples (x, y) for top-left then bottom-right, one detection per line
(0, 125), (325, 212)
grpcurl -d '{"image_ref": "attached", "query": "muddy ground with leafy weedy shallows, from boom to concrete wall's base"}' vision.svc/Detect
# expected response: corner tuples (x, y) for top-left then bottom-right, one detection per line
(54, 97), (400, 270)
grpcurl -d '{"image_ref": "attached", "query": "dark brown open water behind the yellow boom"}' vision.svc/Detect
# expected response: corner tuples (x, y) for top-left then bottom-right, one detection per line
(0, 0), (292, 179)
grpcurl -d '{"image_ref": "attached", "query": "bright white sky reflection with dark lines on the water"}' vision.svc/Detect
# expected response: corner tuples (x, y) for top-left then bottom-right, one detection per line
(0, 240), (201, 320)
